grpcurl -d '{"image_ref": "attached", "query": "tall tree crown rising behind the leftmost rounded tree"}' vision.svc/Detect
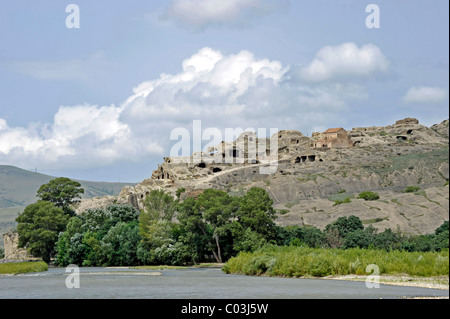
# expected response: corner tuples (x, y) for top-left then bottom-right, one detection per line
(36, 177), (84, 212)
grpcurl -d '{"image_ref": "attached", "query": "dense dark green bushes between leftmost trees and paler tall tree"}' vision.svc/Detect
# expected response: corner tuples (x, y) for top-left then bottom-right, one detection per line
(55, 205), (142, 266)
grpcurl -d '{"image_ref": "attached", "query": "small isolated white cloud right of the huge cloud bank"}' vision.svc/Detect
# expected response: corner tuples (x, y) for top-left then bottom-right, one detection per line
(301, 42), (389, 82)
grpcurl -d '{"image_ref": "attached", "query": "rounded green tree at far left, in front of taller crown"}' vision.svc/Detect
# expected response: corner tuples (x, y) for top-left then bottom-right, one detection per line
(16, 201), (70, 262)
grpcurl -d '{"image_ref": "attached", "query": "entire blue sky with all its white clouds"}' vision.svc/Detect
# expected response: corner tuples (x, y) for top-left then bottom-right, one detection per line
(0, 0), (449, 183)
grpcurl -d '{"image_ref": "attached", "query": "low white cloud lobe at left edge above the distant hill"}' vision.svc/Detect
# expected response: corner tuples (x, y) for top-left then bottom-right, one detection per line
(0, 104), (162, 168)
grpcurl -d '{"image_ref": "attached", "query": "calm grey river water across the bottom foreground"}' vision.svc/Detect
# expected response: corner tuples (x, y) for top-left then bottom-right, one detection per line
(0, 268), (449, 299)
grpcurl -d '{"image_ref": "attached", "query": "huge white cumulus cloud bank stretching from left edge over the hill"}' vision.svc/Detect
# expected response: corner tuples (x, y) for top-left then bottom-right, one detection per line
(0, 43), (382, 169)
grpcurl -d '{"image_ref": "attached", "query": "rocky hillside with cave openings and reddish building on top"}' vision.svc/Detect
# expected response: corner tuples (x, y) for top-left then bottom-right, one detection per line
(78, 118), (449, 234)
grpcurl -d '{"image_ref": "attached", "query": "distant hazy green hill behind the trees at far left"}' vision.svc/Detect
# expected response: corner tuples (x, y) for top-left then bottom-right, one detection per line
(0, 165), (133, 245)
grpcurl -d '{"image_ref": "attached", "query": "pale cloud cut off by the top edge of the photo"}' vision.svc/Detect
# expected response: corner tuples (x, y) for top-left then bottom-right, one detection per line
(166, 0), (288, 29)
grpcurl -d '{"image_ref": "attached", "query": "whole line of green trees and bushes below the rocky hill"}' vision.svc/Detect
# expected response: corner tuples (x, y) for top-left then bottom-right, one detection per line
(16, 178), (449, 266)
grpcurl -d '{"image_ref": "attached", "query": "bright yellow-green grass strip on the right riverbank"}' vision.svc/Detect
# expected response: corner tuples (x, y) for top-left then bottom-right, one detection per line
(222, 246), (449, 277)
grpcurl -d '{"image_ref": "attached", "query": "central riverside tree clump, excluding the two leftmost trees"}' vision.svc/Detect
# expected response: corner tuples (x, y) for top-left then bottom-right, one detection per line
(55, 188), (277, 266)
